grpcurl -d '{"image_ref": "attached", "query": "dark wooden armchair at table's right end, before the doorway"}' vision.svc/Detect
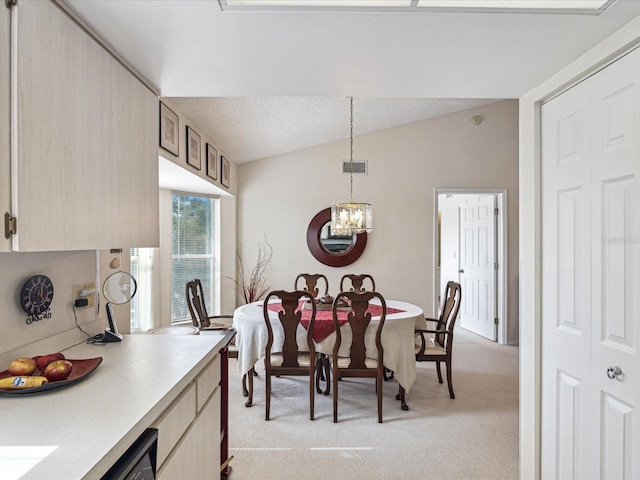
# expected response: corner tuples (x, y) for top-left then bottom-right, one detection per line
(416, 282), (462, 398)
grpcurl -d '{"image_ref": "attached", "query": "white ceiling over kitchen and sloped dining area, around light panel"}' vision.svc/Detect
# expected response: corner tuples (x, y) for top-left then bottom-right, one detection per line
(67, 0), (640, 163)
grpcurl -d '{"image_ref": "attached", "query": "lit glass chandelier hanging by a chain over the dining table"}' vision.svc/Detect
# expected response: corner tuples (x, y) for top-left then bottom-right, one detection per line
(331, 97), (373, 235)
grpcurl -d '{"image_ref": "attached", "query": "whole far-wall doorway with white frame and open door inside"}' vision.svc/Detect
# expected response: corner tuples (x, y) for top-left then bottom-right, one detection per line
(434, 189), (507, 344)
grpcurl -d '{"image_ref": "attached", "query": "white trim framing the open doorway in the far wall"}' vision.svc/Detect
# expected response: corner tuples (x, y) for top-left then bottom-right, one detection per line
(432, 188), (509, 345)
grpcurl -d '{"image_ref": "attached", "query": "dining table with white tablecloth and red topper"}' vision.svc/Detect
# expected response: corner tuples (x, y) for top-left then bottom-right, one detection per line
(233, 299), (427, 408)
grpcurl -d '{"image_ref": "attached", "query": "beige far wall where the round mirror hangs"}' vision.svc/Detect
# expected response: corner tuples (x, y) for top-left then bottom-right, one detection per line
(238, 99), (518, 342)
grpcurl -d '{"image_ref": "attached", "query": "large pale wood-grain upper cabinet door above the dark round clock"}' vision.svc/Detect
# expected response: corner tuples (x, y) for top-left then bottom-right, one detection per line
(11, 1), (159, 251)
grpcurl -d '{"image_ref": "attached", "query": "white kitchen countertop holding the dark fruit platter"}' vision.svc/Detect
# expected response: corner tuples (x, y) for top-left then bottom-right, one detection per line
(0, 334), (230, 480)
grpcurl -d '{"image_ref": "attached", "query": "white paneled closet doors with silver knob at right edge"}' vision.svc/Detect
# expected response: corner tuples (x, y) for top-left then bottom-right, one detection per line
(541, 46), (640, 479)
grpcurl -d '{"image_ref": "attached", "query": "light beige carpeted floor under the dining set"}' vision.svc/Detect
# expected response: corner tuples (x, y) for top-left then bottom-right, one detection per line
(229, 329), (519, 480)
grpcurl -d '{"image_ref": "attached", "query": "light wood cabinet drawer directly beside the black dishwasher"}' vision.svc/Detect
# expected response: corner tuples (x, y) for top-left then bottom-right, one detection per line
(155, 384), (196, 466)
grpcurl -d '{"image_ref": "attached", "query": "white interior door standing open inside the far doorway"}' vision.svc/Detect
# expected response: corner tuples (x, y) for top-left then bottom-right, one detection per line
(460, 195), (497, 341)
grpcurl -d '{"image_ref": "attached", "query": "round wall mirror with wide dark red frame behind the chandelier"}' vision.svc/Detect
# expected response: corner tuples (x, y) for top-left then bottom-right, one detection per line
(307, 208), (367, 267)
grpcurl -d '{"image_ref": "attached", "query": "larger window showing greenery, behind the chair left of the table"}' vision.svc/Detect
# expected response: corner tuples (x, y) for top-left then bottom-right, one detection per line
(171, 194), (218, 323)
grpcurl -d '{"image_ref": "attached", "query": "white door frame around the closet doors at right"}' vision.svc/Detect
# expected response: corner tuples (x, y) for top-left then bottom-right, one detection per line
(519, 17), (640, 479)
